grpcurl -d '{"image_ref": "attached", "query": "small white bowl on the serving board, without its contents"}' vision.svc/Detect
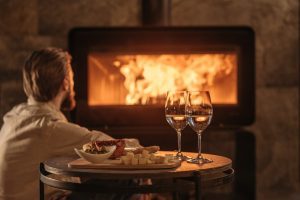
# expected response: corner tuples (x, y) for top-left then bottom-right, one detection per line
(74, 145), (117, 163)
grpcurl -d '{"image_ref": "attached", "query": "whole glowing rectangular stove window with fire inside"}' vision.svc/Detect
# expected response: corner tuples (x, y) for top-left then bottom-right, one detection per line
(88, 53), (237, 105)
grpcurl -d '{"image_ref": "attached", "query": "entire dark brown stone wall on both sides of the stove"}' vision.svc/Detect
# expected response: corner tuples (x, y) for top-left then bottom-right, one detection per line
(0, 0), (300, 199)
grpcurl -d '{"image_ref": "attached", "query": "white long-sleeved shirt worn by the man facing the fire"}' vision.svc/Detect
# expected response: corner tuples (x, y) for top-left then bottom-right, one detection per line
(0, 100), (112, 200)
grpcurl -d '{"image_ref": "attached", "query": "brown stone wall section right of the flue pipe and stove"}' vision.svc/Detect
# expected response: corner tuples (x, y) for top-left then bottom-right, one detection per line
(172, 0), (300, 199)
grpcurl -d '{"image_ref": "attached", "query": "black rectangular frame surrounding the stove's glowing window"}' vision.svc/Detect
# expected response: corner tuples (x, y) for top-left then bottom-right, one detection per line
(69, 27), (255, 127)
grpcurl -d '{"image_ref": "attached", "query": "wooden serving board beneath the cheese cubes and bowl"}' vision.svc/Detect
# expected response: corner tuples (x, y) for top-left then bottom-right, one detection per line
(68, 158), (181, 170)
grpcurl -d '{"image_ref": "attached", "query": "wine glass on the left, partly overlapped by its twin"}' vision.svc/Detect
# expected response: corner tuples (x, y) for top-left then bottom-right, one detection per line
(165, 91), (187, 160)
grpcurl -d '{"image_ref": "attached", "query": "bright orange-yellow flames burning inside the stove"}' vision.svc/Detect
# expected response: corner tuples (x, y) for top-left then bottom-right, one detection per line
(113, 54), (237, 105)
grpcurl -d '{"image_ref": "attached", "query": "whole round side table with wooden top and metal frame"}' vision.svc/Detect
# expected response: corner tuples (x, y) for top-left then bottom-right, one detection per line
(40, 151), (234, 199)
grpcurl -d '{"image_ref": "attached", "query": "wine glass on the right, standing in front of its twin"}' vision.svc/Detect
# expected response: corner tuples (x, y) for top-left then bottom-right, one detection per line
(185, 91), (213, 164)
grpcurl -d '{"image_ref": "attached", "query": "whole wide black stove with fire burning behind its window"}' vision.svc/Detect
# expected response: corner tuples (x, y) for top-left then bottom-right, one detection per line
(69, 27), (255, 129)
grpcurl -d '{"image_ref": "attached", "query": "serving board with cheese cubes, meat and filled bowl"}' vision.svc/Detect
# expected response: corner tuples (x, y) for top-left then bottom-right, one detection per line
(68, 139), (180, 169)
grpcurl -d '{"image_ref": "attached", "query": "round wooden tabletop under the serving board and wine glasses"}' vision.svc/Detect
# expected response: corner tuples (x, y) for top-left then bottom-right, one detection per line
(44, 151), (232, 179)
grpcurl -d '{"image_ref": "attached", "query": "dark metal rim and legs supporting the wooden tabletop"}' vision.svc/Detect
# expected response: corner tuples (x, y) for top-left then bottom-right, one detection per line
(40, 153), (234, 200)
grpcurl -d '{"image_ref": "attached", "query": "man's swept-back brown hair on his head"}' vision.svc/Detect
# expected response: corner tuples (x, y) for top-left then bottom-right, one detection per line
(23, 48), (71, 102)
